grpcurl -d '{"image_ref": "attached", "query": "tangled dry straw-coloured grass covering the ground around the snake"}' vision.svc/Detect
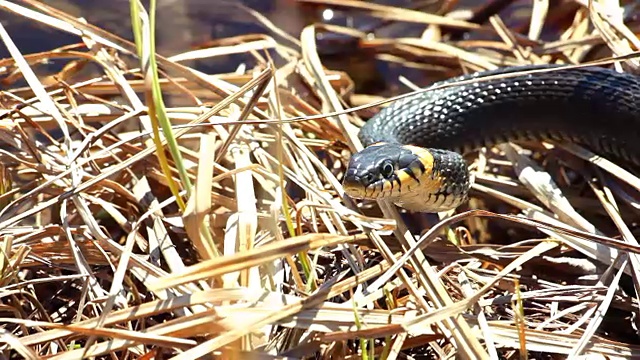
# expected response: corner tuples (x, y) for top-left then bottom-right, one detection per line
(0, 0), (640, 359)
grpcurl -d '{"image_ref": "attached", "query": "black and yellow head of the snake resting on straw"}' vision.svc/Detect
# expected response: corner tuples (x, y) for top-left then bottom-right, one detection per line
(342, 143), (470, 212)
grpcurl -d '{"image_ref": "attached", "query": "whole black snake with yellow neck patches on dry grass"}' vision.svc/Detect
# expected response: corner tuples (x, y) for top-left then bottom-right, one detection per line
(342, 64), (640, 213)
